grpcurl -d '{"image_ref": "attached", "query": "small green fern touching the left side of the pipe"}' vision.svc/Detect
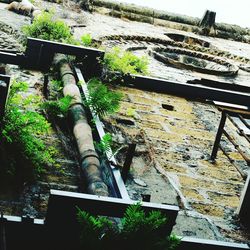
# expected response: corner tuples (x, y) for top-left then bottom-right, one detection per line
(42, 96), (72, 117)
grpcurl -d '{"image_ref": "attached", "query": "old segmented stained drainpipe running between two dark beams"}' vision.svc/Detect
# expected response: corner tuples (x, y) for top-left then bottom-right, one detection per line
(54, 54), (109, 196)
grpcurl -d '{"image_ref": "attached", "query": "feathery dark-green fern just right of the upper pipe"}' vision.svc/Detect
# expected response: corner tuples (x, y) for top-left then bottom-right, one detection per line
(84, 78), (122, 116)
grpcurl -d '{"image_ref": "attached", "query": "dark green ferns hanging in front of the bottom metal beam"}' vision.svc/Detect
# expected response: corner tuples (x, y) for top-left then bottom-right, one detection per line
(77, 204), (179, 250)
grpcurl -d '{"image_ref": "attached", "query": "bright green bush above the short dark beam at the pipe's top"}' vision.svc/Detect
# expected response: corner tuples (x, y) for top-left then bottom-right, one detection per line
(23, 11), (76, 44)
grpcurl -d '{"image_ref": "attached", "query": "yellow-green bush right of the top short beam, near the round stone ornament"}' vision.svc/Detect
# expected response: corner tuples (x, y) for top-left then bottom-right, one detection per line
(104, 47), (148, 75)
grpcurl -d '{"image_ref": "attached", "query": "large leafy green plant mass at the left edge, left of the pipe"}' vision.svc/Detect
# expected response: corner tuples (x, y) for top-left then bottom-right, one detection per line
(0, 82), (57, 182)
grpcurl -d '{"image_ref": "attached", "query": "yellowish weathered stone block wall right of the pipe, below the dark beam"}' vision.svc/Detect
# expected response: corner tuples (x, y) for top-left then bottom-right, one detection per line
(103, 87), (248, 238)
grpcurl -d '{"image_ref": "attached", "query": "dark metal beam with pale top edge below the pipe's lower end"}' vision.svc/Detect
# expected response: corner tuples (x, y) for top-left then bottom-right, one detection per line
(45, 190), (179, 234)
